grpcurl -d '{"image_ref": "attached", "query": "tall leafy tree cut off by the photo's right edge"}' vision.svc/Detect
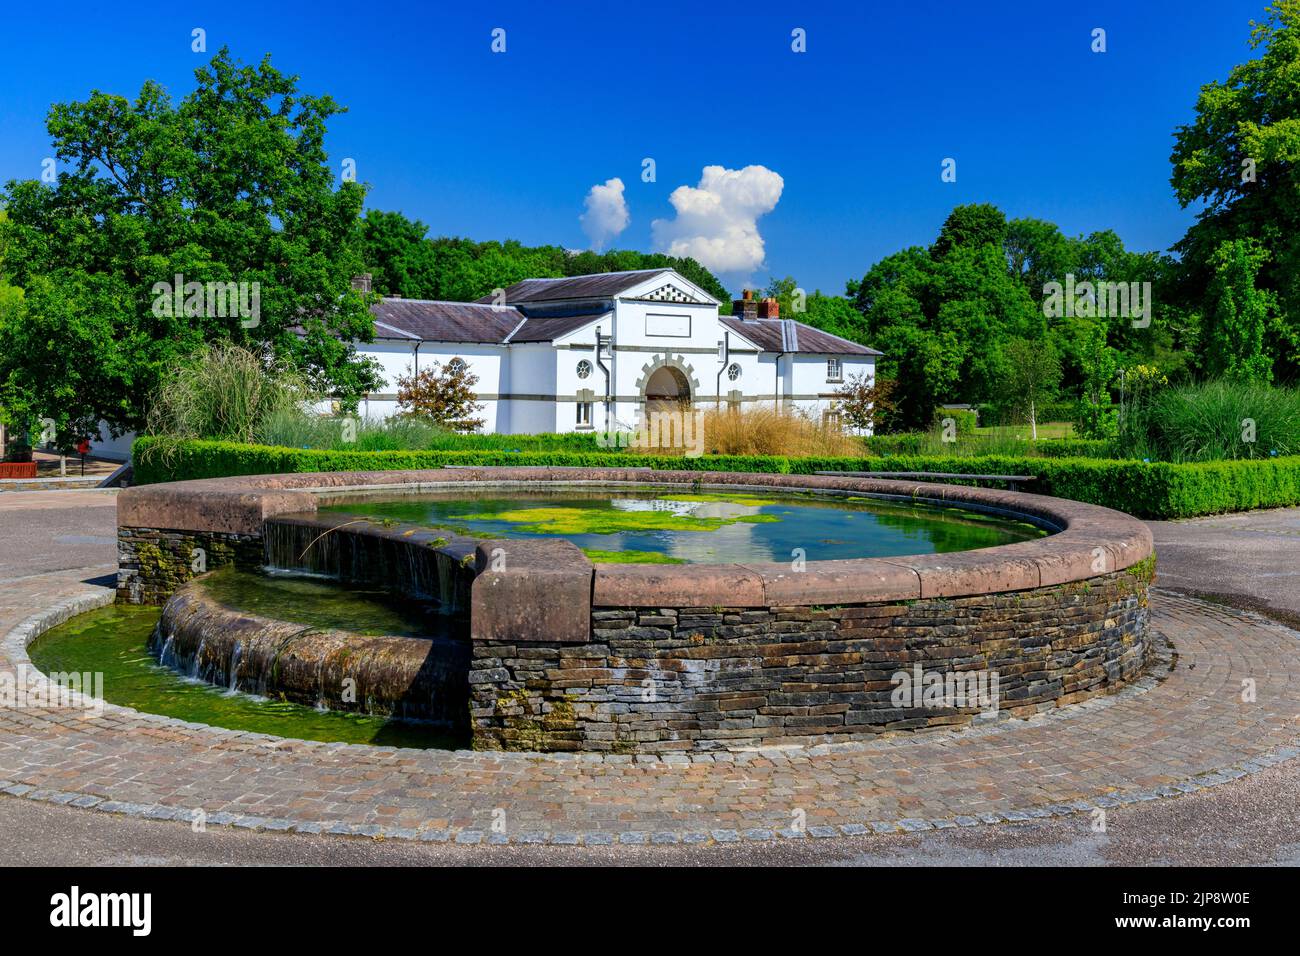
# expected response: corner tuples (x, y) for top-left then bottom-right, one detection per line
(1171, 0), (1300, 378)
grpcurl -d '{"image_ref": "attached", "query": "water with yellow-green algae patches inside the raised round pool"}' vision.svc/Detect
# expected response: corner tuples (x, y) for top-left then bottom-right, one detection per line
(321, 488), (1044, 564)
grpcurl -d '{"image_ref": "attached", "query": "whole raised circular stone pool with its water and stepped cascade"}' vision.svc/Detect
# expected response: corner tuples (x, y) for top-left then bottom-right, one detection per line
(101, 467), (1154, 753)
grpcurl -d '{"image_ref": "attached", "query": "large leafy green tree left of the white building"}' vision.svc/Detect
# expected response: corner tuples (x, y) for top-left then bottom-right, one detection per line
(0, 49), (376, 445)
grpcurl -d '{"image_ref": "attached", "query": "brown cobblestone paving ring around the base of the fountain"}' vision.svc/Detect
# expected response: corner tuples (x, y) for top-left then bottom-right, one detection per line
(0, 575), (1300, 845)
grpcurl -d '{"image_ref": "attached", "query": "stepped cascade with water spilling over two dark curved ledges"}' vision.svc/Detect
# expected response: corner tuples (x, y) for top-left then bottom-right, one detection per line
(151, 515), (477, 728)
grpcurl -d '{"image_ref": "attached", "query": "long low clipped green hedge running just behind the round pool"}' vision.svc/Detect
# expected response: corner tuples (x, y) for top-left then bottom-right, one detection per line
(134, 438), (1300, 519)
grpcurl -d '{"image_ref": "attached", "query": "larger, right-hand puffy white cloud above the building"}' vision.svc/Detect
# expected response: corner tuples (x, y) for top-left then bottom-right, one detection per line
(650, 166), (785, 274)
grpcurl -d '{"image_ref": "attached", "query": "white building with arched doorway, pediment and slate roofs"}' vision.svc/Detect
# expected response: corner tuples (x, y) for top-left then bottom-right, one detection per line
(356, 269), (880, 433)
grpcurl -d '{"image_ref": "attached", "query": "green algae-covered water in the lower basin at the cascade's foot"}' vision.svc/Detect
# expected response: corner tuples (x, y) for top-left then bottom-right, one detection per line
(29, 600), (465, 749)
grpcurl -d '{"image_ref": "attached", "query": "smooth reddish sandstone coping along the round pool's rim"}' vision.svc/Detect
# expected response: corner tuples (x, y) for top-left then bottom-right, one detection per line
(117, 467), (1152, 607)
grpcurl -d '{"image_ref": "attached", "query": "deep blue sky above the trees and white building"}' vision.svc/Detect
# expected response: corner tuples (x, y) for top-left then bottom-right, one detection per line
(0, 0), (1265, 291)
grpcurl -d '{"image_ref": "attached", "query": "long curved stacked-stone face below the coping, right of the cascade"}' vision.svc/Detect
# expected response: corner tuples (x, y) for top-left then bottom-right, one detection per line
(469, 562), (1153, 753)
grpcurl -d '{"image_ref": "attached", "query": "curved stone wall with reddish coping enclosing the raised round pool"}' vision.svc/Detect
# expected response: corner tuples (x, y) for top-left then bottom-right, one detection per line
(118, 468), (1153, 752)
